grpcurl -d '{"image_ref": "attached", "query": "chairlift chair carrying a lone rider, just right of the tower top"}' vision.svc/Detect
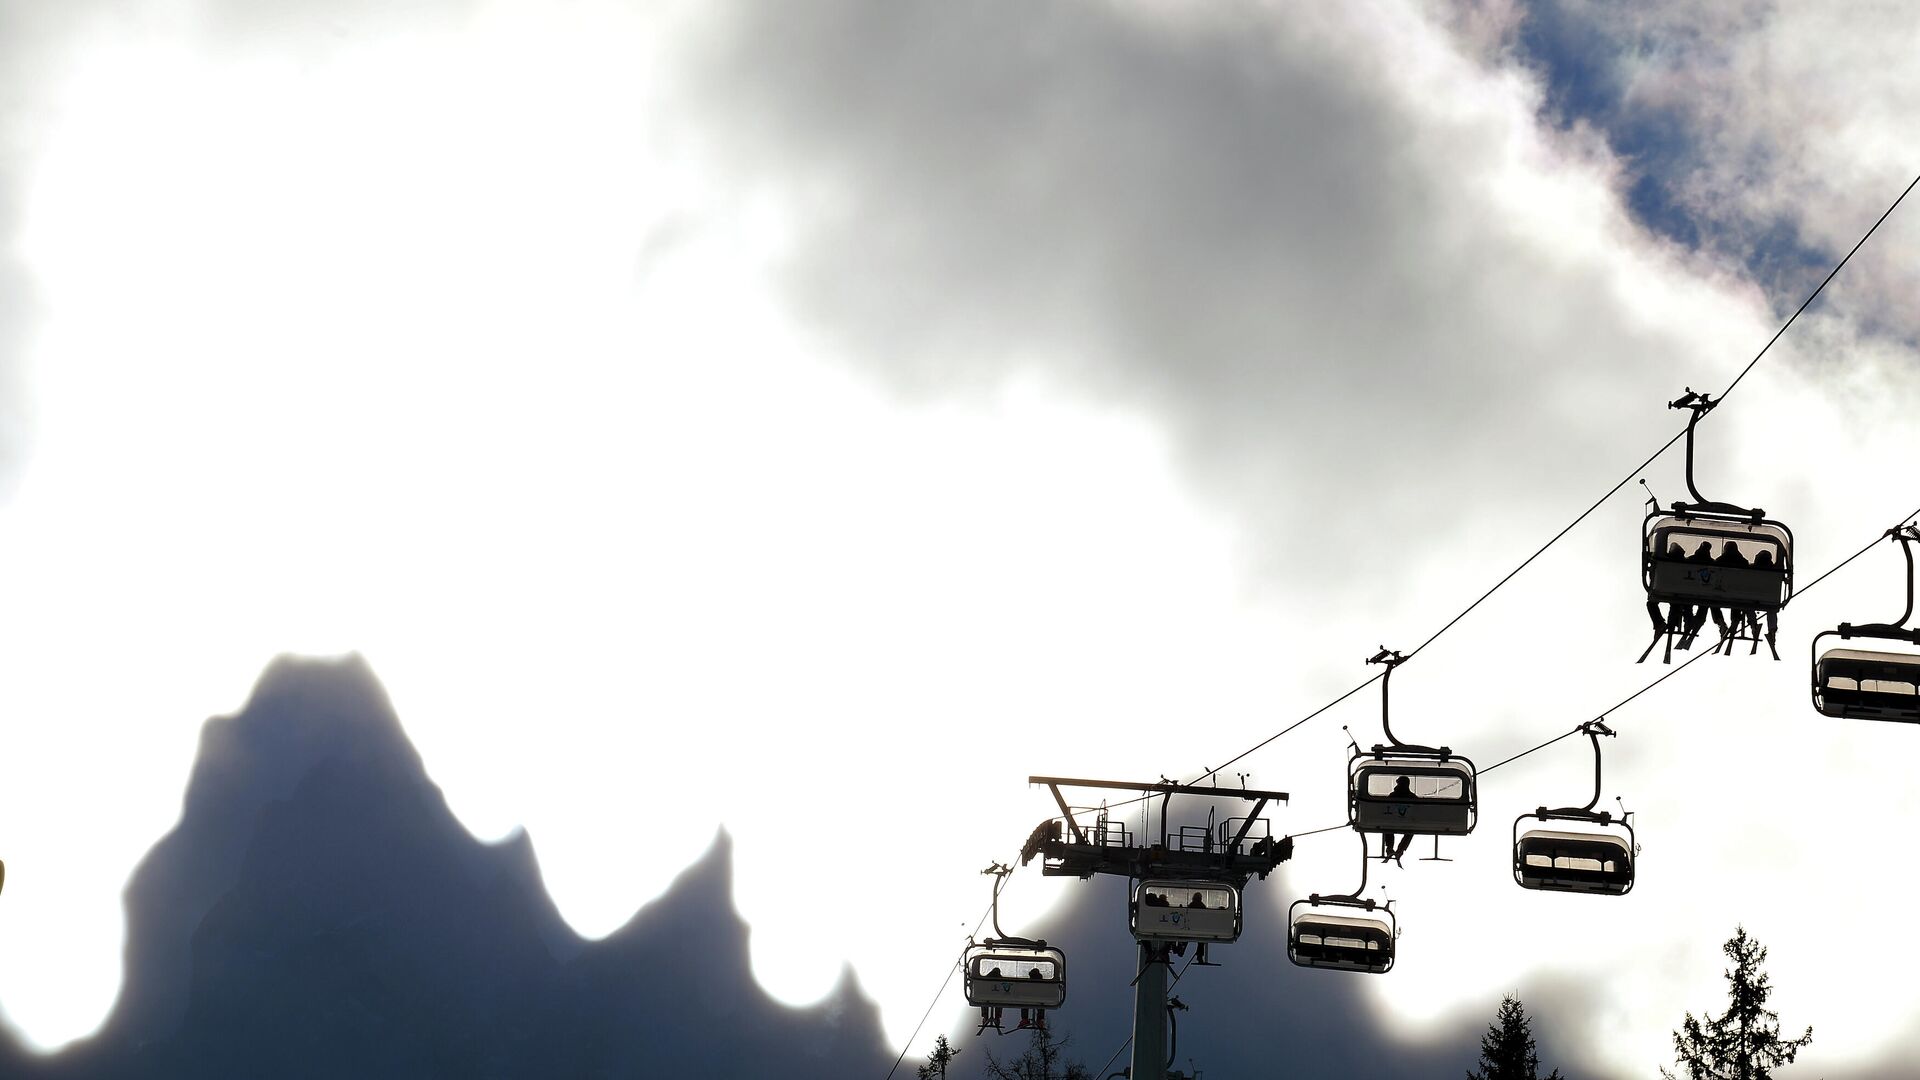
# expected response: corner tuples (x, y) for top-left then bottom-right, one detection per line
(1346, 648), (1480, 836)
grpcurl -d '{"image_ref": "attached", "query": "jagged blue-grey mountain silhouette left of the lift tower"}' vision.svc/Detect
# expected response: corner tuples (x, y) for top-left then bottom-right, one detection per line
(0, 655), (893, 1080)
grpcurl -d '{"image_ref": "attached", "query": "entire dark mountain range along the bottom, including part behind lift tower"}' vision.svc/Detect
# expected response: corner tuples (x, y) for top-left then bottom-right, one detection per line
(0, 655), (1681, 1080)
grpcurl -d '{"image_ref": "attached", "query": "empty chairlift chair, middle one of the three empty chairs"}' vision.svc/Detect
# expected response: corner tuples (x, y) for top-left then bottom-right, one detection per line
(1513, 721), (1640, 896)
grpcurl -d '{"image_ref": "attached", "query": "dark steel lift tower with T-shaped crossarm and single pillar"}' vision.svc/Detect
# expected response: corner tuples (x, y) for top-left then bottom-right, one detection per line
(1020, 776), (1294, 1080)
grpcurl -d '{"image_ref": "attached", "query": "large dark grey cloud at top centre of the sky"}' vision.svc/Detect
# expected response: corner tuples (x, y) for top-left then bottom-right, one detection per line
(695, 0), (1704, 588)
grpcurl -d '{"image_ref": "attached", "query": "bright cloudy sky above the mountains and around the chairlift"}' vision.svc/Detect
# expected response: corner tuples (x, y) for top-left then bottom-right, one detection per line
(0, 0), (1920, 1076)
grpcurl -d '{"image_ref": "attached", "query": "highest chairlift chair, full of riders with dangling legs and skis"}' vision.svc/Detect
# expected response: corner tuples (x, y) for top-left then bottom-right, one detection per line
(1640, 388), (1793, 663)
